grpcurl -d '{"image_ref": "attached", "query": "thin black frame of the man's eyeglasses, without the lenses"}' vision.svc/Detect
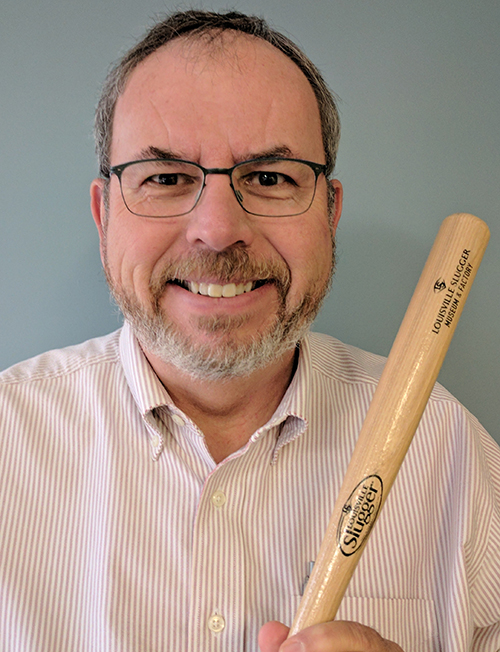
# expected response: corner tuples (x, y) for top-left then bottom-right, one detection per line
(106, 156), (327, 219)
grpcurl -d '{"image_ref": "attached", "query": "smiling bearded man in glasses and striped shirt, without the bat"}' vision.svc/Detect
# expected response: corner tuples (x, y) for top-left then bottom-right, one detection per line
(0, 11), (500, 652)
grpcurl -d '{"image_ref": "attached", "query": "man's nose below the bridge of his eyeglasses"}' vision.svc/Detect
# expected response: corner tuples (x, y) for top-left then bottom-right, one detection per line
(186, 175), (254, 251)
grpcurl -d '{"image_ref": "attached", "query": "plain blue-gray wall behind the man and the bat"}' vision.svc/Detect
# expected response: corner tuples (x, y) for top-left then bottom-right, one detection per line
(0, 0), (500, 440)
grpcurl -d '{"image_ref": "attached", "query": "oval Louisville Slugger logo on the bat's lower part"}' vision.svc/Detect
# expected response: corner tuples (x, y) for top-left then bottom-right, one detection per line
(337, 475), (383, 557)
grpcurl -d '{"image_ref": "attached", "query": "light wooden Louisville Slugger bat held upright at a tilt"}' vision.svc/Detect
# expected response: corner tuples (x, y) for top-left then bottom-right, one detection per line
(289, 213), (489, 636)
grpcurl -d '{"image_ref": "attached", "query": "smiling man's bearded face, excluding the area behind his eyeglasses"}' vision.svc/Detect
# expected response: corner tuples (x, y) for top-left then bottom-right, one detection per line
(91, 34), (341, 377)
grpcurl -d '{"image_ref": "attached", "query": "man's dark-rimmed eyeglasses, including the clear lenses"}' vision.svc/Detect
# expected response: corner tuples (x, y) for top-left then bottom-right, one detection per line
(110, 158), (326, 217)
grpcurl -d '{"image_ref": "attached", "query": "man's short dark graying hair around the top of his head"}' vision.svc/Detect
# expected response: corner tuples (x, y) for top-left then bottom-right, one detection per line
(94, 9), (340, 178)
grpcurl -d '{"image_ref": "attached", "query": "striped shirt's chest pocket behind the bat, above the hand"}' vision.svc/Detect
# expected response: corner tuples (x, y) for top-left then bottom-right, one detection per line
(292, 596), (441, 652)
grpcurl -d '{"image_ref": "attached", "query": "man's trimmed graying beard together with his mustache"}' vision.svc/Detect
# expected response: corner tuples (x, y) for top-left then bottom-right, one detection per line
(105, 247), (333, 380)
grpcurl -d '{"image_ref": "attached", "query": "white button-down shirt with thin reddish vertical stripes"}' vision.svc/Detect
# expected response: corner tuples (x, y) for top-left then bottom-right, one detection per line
(0, 324), (500, 652)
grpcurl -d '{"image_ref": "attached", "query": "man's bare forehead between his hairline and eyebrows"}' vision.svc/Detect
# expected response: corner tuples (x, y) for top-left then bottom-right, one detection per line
(112, 32), (323, 167)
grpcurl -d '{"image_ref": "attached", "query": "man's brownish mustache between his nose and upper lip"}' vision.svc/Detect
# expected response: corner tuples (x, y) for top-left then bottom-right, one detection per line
(150, 247), (292, 303)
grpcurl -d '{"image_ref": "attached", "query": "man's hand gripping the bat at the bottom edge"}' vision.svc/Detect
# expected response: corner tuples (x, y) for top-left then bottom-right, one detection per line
(259, 620), (403, 652)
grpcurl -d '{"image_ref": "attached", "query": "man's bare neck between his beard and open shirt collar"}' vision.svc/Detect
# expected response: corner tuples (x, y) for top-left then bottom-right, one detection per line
(146, 351), (295, 463)
